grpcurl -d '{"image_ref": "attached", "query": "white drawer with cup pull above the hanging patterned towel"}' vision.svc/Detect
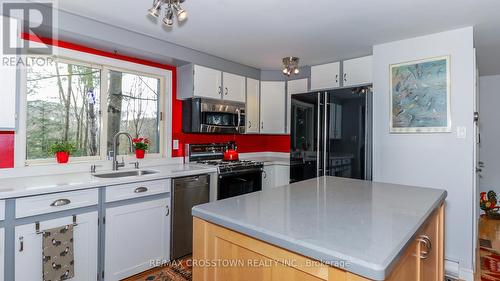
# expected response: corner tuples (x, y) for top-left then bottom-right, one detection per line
(16, 188), (99, 218)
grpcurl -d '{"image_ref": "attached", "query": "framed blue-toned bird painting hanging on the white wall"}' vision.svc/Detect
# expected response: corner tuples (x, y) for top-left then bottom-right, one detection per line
(390, 56), (451, 133)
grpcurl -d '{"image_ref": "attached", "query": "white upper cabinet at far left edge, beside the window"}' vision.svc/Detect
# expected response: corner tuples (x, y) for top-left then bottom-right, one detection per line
(0, 16), (17, 131)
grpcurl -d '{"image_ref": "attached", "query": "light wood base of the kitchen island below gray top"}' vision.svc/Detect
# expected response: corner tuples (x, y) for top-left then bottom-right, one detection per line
(193, 203), (444, 281)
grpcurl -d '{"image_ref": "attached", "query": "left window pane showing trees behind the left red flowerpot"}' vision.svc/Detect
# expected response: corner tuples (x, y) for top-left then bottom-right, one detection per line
(26, 62), (101, 159)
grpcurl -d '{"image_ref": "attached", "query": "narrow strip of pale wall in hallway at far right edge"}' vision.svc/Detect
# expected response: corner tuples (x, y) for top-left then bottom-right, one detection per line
(479, 75), (500, 194)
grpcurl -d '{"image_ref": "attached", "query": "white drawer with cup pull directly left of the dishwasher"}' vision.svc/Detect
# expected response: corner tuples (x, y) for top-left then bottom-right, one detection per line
(106, 180), (170, 202)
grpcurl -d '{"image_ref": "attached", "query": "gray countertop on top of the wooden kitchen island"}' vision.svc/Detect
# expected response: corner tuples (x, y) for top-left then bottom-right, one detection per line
(193, 177), (447, 280)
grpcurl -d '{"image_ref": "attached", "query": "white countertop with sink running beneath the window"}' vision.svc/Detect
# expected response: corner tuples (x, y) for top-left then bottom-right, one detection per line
(0, 164), (217, 200)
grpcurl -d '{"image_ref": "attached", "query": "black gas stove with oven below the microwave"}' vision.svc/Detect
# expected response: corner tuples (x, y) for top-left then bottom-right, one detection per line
(186, 143), (264, 200)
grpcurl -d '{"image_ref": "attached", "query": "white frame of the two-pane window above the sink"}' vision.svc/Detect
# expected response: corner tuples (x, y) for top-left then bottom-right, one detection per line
(14, 46), (173, 167)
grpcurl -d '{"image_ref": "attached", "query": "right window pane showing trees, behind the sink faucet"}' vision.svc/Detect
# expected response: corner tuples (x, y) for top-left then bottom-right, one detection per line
(107, 71), (160, 155)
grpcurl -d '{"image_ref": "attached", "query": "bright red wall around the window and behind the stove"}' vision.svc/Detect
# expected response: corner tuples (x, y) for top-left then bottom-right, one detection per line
(0, 34), (290, 168)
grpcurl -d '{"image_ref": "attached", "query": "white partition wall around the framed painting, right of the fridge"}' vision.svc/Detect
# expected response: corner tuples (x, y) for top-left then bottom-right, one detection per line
(373, 27), (474, 275)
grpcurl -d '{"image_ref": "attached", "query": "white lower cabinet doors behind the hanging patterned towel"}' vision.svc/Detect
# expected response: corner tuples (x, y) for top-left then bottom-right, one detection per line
(15, 212), (98, 281)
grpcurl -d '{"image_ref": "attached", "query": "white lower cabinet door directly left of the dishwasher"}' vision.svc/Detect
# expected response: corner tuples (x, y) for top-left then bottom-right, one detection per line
(104, 198), (170, 281)
